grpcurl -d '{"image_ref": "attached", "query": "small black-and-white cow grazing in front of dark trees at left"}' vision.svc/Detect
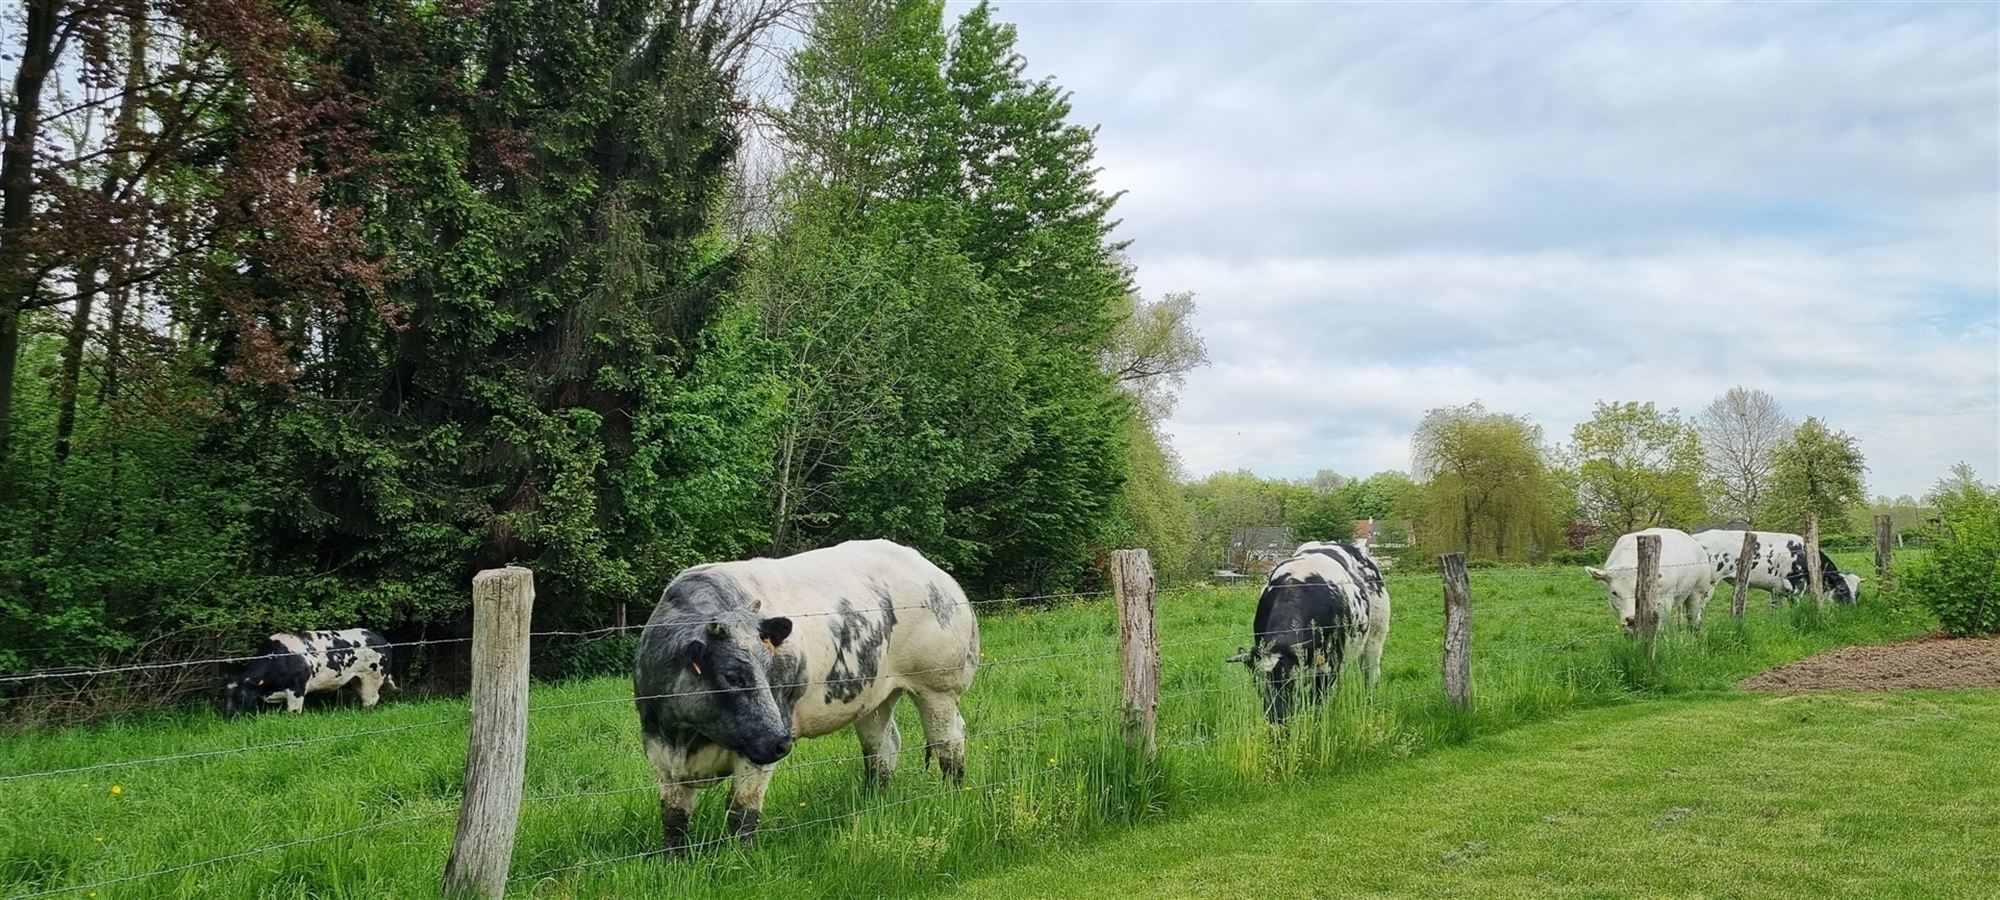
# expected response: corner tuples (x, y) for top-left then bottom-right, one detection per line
(222, 628), (396, 716)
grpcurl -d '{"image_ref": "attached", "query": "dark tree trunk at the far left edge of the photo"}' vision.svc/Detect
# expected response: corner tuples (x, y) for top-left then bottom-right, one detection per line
(0, 0), (62, 460)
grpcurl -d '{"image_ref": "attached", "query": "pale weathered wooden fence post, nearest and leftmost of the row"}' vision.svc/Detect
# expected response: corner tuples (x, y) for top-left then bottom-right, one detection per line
(444, 566), (534, 898)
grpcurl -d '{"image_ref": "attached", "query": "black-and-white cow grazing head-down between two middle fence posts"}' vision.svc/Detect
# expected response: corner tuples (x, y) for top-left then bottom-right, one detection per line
(1230, 542), (1390, 724)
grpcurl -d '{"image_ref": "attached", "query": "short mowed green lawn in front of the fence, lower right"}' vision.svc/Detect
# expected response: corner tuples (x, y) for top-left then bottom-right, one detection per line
(936, 690), (2000, 900)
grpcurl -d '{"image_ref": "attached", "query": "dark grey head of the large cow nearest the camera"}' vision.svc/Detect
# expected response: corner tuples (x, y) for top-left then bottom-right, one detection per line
(664, 608), (794, 766)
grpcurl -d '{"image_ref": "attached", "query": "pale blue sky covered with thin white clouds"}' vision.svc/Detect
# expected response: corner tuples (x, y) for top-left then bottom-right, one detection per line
(980, 0), (2000, 494)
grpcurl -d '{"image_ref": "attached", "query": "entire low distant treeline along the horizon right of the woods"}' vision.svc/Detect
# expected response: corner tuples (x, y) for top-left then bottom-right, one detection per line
(1186, 388), (1896, 568)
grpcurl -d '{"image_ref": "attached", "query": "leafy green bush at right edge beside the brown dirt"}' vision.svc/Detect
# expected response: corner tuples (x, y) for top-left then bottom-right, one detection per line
(1898, 462), (2000, 636)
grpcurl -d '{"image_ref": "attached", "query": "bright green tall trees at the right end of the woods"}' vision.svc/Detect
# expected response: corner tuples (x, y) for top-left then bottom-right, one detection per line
(754, 0), (1144, 592)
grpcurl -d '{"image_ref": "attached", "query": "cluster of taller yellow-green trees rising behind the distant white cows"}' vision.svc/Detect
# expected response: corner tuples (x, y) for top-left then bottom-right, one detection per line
(1406, 388), (1870, 562)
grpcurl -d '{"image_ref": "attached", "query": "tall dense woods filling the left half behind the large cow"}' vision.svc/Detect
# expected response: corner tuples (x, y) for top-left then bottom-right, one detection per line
(0, 0), (1202, 668)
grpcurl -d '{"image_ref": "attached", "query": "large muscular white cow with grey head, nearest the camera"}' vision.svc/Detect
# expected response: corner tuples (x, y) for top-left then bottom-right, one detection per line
(634, 540), (980, 854)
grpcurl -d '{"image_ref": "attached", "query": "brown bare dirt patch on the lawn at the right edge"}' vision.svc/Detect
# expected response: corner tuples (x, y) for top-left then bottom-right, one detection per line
(1738, 636), (2000, 692)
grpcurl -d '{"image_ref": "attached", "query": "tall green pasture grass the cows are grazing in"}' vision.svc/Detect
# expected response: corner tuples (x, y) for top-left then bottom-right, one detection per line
(0, 568), (1928, 898)
